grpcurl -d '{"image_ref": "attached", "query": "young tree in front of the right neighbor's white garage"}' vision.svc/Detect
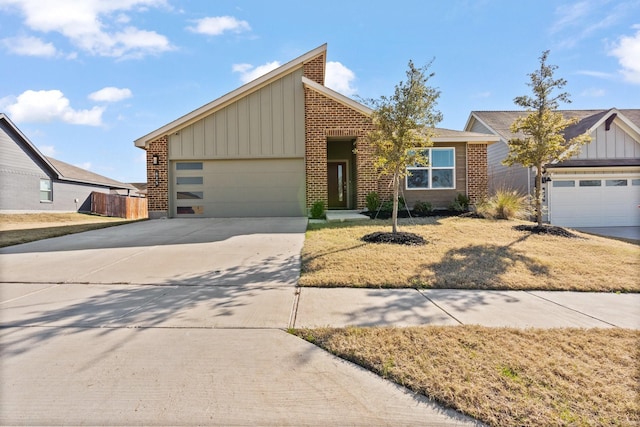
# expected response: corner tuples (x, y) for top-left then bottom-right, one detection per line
(503, 50), (591, 227)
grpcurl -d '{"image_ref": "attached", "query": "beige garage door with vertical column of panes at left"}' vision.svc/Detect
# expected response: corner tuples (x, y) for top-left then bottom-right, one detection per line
(171, 159), (306, 218)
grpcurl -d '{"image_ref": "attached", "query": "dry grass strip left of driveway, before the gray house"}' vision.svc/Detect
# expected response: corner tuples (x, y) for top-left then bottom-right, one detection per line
(0, 213), (139, 247)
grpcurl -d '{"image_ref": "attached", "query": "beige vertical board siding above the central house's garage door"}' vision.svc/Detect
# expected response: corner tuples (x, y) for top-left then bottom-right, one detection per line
(169, 69), (304, 160)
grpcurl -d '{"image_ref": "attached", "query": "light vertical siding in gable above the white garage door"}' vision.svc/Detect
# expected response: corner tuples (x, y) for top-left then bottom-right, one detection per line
(574, 122), (640, 159)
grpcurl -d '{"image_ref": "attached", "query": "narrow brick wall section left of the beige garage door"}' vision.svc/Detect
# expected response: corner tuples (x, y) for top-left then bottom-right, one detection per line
(147, 136), (169, 218)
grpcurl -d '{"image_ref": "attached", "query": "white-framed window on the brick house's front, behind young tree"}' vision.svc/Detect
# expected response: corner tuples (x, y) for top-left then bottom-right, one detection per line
(406, 147), (456, 190)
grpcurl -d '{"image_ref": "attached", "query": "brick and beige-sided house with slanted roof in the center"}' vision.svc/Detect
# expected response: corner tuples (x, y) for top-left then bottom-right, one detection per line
(135, 44), (499, 218)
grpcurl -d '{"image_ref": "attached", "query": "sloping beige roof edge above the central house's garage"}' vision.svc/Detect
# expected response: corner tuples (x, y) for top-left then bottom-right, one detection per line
(134, 43), (327, 148)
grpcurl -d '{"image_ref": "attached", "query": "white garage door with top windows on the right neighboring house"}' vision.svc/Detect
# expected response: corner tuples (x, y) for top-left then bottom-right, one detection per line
(549, 176), (640, 227)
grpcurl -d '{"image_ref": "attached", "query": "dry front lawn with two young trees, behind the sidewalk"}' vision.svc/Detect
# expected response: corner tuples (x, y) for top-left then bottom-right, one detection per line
(300, 217), (640, 292)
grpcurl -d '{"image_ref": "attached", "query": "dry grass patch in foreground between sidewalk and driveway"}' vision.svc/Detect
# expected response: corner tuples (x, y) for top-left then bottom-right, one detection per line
(295, 326), (640, 426)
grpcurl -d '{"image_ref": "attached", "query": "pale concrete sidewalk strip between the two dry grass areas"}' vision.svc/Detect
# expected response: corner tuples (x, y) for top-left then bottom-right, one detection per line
(293, 288), (640, 329)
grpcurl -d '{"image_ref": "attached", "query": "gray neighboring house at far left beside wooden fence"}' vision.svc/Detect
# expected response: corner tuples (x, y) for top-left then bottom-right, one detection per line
(0, 113), (135, 212)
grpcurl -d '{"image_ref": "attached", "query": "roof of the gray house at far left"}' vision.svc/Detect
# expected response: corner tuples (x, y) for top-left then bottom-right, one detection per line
(0, 113), (135, 190)
